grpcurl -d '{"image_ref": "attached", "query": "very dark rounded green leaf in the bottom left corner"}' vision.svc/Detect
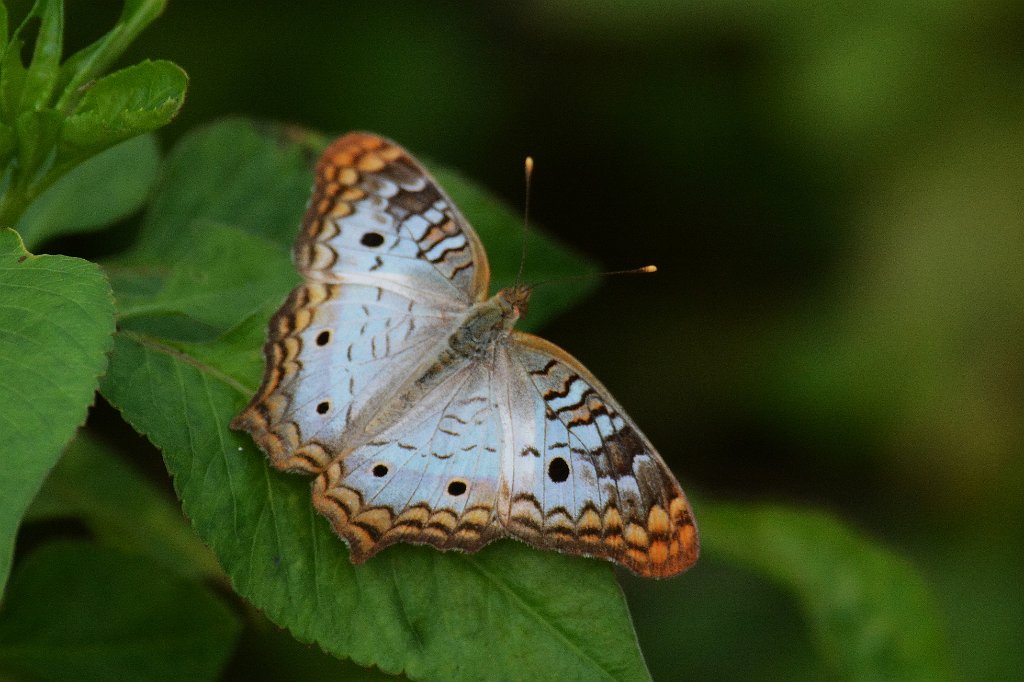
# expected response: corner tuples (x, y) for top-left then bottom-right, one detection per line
(0, 543), (239, 681)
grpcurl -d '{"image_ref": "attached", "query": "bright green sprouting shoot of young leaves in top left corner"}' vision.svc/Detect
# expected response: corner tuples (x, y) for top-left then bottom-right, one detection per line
(0, 0), (187, 225)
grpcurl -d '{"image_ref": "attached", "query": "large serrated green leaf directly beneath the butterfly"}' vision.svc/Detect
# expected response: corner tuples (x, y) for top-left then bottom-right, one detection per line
(103, 325), (644, 679)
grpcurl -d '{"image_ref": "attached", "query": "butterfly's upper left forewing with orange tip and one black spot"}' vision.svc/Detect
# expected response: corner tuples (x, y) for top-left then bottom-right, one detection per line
(295, 133), (489, 306)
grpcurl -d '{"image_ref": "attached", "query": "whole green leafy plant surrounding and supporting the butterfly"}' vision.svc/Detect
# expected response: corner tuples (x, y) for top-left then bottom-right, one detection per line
(0, 1), (949, 679)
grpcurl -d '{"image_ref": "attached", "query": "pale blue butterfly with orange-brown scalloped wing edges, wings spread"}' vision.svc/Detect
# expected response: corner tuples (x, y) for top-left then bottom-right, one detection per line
(231, 132), (698, 578)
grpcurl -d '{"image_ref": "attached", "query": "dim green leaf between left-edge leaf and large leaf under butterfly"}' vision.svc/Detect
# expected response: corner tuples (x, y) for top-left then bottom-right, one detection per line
(25, 429), (223, 580)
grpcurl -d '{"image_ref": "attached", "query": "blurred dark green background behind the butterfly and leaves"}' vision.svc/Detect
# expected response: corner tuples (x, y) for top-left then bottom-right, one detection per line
(49, 0), (1024, 679)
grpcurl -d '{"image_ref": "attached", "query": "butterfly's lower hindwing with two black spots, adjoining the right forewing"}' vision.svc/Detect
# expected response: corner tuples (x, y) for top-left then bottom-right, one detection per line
(313, 359), (503, 563)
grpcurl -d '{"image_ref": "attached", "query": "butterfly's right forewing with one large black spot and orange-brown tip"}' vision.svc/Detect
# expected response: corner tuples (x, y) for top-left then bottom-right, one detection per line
(497, 332), (699, 578)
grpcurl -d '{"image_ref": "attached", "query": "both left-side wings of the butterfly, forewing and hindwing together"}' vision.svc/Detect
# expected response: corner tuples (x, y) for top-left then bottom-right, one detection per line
(231, 133), (488, 473)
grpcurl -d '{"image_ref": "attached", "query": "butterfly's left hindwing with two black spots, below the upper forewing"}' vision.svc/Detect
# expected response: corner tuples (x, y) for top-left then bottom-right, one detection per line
(232, 283), (457, 472)
